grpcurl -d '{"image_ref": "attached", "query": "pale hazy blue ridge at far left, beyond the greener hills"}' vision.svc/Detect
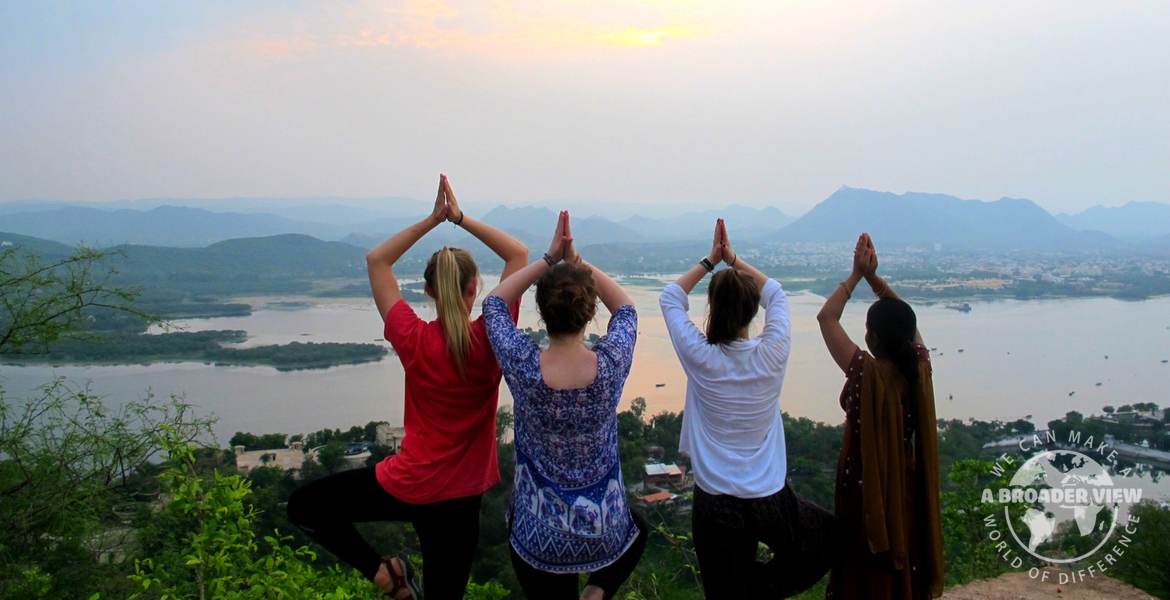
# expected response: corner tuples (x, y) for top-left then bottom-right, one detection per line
(4, 206), (349, 247)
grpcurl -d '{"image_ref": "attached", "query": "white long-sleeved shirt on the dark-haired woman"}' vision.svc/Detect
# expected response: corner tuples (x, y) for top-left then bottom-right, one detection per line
(660, 280), (791, 498)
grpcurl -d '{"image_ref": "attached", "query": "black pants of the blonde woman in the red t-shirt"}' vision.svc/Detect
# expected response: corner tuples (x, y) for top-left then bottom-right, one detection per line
(288, 467), (481, 600)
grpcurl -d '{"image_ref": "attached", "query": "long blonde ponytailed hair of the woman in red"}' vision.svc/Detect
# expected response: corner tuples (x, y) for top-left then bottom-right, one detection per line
(422, 246), (479, 374)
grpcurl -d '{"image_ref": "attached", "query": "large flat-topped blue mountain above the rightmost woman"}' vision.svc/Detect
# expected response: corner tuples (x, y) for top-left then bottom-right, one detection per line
(776, 187), (1108, 249)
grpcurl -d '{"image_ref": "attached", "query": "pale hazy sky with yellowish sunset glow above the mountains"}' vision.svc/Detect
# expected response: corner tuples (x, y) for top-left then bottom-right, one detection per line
(0, 0), (1170, 212)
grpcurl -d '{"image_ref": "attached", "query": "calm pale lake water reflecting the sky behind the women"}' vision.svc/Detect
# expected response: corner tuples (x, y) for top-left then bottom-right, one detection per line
(0, 273), (1170, 456)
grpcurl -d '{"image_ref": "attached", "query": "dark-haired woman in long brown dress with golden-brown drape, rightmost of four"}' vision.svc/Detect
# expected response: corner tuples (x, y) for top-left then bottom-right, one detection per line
(817, 234), (943, 600)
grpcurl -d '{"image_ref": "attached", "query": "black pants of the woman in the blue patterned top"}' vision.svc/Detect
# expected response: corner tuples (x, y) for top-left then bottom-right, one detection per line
(510, 512), (649, 600)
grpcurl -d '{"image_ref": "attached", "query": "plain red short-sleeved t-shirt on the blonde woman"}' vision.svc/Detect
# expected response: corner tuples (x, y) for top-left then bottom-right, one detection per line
(374, 299), (519, 504)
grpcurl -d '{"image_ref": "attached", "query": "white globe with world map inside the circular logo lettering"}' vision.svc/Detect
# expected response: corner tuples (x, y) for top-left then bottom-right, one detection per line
(1004, 450), (1117, 563)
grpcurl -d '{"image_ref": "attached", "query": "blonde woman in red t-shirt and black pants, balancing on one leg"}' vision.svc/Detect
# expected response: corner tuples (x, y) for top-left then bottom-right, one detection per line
(288, 175), (528, 600)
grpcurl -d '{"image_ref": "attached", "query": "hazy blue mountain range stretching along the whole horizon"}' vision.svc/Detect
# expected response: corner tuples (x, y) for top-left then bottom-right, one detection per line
(0, 187), (1170, 250)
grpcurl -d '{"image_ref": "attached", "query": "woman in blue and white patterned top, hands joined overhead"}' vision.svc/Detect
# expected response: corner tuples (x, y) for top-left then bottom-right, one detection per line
(483, 212), (647, 600)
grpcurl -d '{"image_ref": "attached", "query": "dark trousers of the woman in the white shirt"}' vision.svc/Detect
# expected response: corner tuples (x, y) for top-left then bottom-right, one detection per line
(691, 485), (837, 600)
